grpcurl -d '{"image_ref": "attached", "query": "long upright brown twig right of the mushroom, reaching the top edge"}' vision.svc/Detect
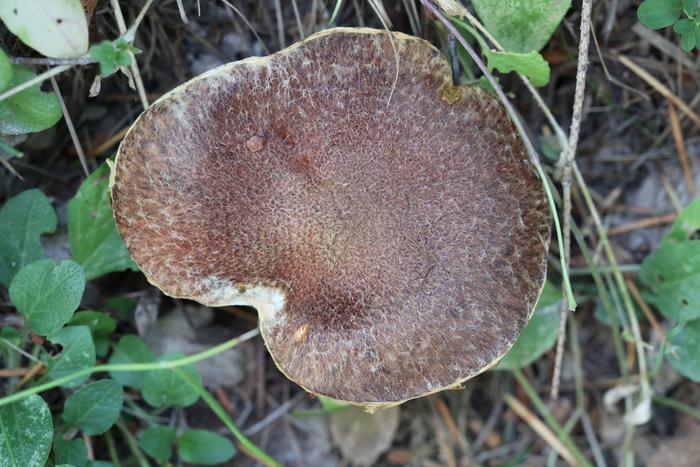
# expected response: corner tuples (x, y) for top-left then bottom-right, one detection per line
(549, 0), (593, 399)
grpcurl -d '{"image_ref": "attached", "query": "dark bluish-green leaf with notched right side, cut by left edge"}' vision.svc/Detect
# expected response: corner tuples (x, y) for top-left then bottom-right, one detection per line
(0, 189), (57, 287)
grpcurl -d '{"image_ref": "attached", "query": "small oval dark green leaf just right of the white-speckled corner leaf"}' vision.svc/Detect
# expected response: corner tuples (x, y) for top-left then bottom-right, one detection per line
(63, 379), (124, 435)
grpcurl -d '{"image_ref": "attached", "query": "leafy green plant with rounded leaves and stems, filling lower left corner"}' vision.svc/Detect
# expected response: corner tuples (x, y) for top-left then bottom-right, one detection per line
(0, 169), (275, 467)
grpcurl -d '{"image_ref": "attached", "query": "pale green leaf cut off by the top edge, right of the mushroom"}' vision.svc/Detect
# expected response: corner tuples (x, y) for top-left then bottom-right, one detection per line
(472, 0), (571, 53)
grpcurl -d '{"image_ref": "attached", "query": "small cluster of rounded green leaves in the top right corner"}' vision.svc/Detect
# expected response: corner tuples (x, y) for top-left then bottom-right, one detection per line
(637, 0), (700, 52)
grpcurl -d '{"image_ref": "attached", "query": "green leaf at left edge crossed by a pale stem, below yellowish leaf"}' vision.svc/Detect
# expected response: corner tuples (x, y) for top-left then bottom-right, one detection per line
(0, 64), (63, 135)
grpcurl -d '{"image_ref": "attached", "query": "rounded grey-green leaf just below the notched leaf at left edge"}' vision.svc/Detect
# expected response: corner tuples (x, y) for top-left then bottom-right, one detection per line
(10, 258), (85, 336)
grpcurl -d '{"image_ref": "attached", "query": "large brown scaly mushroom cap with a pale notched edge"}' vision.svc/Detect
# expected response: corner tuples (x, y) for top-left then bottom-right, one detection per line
(112, 28), (550, 407)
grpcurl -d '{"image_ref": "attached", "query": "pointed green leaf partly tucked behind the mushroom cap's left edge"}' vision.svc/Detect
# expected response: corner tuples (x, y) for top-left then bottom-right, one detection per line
(68, 164), (138, 280)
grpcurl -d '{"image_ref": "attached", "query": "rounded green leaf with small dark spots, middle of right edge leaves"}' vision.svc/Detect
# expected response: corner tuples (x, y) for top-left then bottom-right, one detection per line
(639, 240), (700, 322)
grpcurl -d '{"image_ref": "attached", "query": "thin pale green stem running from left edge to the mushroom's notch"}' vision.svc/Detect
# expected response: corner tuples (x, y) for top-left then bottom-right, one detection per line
(0, 329), (260, 407)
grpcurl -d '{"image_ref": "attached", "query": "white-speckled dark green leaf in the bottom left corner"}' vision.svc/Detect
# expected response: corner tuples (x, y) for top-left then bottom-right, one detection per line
(0, 394), (53, 467)
